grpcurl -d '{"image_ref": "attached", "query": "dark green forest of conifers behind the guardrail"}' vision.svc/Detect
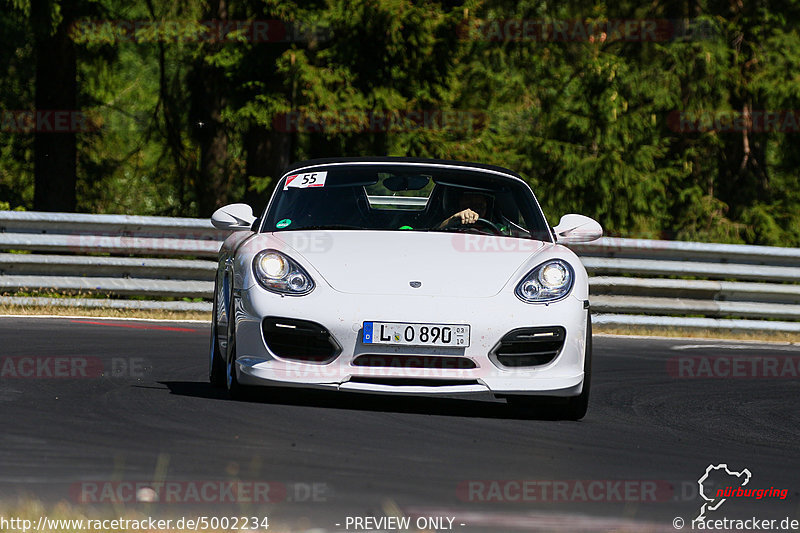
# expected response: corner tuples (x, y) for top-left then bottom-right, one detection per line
(0, 0), (800, 246)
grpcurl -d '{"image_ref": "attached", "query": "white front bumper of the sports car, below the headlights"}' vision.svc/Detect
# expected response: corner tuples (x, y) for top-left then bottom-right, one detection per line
(234, 285), (587, 396)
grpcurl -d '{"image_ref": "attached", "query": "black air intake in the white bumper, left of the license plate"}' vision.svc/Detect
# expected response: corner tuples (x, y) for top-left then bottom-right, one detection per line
(261, 317), (341, 363)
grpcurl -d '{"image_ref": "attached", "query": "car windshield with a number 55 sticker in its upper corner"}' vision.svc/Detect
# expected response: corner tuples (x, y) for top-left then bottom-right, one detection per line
(261, 160), (551, 241)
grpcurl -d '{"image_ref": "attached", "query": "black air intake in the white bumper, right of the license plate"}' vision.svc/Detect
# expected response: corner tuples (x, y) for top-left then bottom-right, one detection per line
(490, 326), (567, 368)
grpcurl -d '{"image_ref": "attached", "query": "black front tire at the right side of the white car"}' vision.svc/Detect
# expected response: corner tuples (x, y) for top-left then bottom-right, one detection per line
(506, 313), (592, 420)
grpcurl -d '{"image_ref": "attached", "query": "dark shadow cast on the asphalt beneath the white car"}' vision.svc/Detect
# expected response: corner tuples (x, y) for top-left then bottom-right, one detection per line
(159, 381), (580, 420)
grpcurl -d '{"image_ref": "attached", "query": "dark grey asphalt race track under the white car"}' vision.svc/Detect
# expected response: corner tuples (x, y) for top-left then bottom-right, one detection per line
(0, 317), (800, 532)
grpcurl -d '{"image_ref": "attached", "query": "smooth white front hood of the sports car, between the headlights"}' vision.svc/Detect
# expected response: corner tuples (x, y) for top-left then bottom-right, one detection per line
(272, 231), (547, 297)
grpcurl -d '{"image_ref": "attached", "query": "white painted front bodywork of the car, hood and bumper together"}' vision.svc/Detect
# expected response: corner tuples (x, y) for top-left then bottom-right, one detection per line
(219, 231), (588, 394)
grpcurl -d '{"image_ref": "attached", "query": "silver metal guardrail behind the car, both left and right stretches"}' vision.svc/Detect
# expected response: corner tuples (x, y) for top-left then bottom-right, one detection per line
(0, 211), (800, 332)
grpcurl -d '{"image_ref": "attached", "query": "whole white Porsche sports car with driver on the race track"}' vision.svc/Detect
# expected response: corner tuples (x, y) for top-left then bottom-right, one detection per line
(209, 157), (602, 419)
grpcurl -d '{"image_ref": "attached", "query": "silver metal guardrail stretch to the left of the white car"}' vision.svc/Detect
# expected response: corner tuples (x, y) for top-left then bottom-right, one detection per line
(0, 211), (219, 311)
